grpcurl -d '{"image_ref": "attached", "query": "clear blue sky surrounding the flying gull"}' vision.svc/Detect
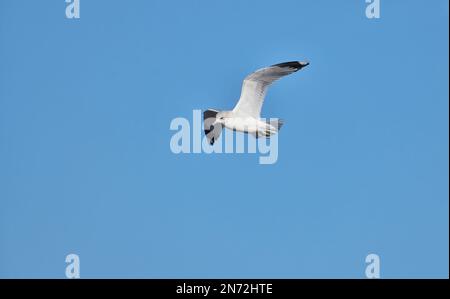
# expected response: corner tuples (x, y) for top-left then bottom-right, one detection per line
(0, 0), (449, 278)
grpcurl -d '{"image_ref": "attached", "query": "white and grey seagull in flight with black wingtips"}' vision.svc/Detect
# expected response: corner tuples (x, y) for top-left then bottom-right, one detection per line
(203, 61), (309, 145)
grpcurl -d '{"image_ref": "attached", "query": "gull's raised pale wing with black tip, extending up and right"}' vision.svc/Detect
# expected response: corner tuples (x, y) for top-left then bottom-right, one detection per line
(233, 61), (309, 118)
